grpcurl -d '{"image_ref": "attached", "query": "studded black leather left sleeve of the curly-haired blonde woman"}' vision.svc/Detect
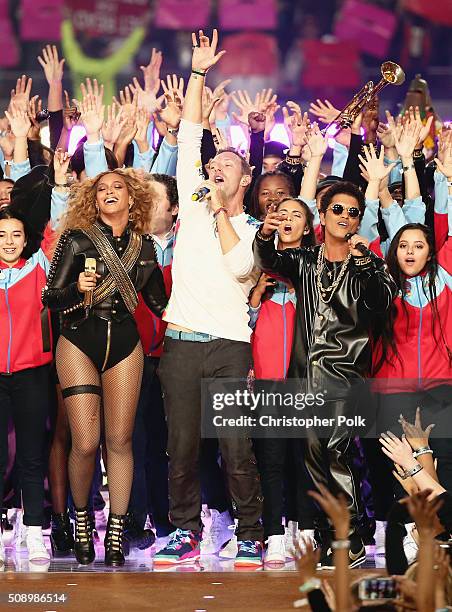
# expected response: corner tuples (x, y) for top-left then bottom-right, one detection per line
(42, 232), (83, 312)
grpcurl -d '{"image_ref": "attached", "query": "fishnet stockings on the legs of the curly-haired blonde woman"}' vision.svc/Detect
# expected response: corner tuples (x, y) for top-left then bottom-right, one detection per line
(56, 336), (143, 514)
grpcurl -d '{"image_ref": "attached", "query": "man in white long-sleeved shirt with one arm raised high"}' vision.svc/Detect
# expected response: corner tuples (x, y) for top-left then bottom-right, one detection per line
(154, 30), (263, 566)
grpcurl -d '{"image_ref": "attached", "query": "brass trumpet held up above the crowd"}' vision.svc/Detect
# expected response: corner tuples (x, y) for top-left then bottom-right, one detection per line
(322, 62), (405, 134)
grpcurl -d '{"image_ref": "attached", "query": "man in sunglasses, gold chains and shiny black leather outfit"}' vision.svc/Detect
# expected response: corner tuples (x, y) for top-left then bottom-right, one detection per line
(254, 182), (395, 567)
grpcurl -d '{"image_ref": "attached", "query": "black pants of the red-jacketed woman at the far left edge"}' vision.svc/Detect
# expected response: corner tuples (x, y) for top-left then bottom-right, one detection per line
(0, 366), (50, 526)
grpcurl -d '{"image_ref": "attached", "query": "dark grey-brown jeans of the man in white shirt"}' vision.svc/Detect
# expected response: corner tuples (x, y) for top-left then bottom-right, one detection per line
(159, 337), (263, 540)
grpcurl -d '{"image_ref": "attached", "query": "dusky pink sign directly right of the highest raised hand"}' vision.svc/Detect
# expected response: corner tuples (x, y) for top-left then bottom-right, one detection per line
(218, 32), (278, 76)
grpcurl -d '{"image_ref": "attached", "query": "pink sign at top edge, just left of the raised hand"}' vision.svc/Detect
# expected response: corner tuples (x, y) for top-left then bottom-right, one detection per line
(154, 0), (210, 31)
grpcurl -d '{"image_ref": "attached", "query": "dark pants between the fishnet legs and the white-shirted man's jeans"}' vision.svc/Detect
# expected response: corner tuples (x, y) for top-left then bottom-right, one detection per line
(129, 357), (174, 537)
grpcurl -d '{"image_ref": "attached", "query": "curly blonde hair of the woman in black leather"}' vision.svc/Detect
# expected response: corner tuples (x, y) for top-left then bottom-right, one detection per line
(60, 168), (156, 234)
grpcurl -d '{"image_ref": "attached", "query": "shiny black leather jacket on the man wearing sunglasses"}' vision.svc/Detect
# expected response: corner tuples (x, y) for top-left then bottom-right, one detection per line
(253, 233), (396, 388)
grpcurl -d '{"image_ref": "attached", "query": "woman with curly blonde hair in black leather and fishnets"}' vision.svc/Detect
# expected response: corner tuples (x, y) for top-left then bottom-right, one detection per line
(43, 170), (167, 565)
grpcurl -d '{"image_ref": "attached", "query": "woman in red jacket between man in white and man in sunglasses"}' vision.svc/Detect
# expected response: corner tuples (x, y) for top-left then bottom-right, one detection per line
(250, 197), (314, 564)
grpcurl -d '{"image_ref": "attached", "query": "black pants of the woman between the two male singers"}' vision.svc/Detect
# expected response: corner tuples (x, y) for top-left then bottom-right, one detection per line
(254, 438), (315, 538)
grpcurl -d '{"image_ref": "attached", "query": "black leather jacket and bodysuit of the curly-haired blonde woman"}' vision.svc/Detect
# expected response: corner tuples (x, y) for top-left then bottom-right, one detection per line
(43, 221), (168, 372)
